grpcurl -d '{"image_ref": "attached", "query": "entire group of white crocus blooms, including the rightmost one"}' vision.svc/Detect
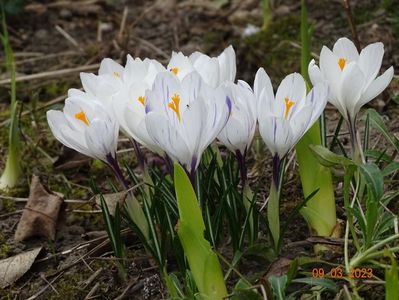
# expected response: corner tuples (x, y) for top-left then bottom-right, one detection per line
(47, 38), (393, 172)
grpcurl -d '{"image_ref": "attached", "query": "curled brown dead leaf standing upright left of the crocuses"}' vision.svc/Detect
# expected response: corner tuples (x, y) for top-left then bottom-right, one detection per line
(14, 175), (64, 241)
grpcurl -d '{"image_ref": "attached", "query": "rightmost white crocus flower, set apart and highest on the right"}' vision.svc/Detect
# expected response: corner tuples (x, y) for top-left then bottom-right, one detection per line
(309, 38), (393, 124)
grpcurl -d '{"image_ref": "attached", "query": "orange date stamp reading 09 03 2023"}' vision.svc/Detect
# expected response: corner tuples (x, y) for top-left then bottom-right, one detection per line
(312, 267), (373, 279)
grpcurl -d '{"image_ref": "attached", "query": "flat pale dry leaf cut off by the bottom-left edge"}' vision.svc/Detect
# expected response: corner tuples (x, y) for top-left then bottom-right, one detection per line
(0, 247), (42, 288)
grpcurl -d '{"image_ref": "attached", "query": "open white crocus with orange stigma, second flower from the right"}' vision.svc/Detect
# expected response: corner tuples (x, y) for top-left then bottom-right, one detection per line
(255, 69), (328, 159)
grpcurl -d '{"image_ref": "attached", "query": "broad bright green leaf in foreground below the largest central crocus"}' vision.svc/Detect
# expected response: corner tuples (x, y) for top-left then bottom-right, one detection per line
(174, 164), (227, 300)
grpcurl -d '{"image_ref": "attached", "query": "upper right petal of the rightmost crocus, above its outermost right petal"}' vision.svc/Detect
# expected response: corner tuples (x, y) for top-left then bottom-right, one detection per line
(358, 42), (384, 86)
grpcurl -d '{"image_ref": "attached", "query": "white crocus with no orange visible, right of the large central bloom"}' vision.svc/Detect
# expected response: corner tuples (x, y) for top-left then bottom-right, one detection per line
(218, 80), (257, 157)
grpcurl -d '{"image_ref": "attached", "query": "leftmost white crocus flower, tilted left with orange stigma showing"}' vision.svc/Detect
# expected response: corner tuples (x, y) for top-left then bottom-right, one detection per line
(47, 95), (119, 165)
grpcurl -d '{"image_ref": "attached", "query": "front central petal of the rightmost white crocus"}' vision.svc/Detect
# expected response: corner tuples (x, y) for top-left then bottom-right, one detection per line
(340, 62), (366, 120)
